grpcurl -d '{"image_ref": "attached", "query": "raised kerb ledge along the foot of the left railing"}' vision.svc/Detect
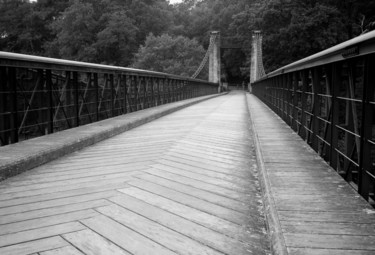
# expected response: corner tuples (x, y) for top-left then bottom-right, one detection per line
(0, 93), (226, 181)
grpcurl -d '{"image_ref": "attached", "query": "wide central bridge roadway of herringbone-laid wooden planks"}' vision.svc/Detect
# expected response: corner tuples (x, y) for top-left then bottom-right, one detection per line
(0, 92), (269, 255)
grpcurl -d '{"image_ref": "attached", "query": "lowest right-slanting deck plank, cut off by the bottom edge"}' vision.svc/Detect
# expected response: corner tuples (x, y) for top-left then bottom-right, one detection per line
(62, 229), (130, 255)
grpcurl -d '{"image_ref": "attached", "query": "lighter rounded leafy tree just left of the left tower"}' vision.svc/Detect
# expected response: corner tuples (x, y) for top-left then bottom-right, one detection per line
(133, 34), (205, 76)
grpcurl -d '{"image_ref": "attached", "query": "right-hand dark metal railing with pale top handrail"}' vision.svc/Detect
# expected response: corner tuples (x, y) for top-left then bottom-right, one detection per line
(252, 31), (375, 203)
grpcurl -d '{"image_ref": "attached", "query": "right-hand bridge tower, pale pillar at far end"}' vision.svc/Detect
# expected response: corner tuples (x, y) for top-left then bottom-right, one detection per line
(249, 31), (266, 92)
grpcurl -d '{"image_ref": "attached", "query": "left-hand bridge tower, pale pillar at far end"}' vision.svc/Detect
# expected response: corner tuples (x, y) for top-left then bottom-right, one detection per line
(208, 31), (221, 86)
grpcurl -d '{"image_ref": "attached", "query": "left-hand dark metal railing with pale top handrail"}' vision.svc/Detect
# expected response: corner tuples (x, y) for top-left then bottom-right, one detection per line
(0, 52), (218, 146)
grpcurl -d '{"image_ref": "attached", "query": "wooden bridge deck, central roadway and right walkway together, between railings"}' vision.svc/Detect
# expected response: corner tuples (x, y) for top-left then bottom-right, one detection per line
(0, 92), (375, 255)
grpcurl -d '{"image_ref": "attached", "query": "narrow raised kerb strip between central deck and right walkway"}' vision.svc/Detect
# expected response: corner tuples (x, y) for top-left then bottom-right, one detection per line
(246, 94), (288, 255)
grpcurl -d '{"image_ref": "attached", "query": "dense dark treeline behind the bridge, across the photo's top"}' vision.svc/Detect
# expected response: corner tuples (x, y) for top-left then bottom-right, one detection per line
(0, 0), (375, 77)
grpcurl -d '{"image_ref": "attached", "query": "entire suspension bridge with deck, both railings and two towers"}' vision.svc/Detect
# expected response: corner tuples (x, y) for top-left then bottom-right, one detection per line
(0, 31), (375, 255)
